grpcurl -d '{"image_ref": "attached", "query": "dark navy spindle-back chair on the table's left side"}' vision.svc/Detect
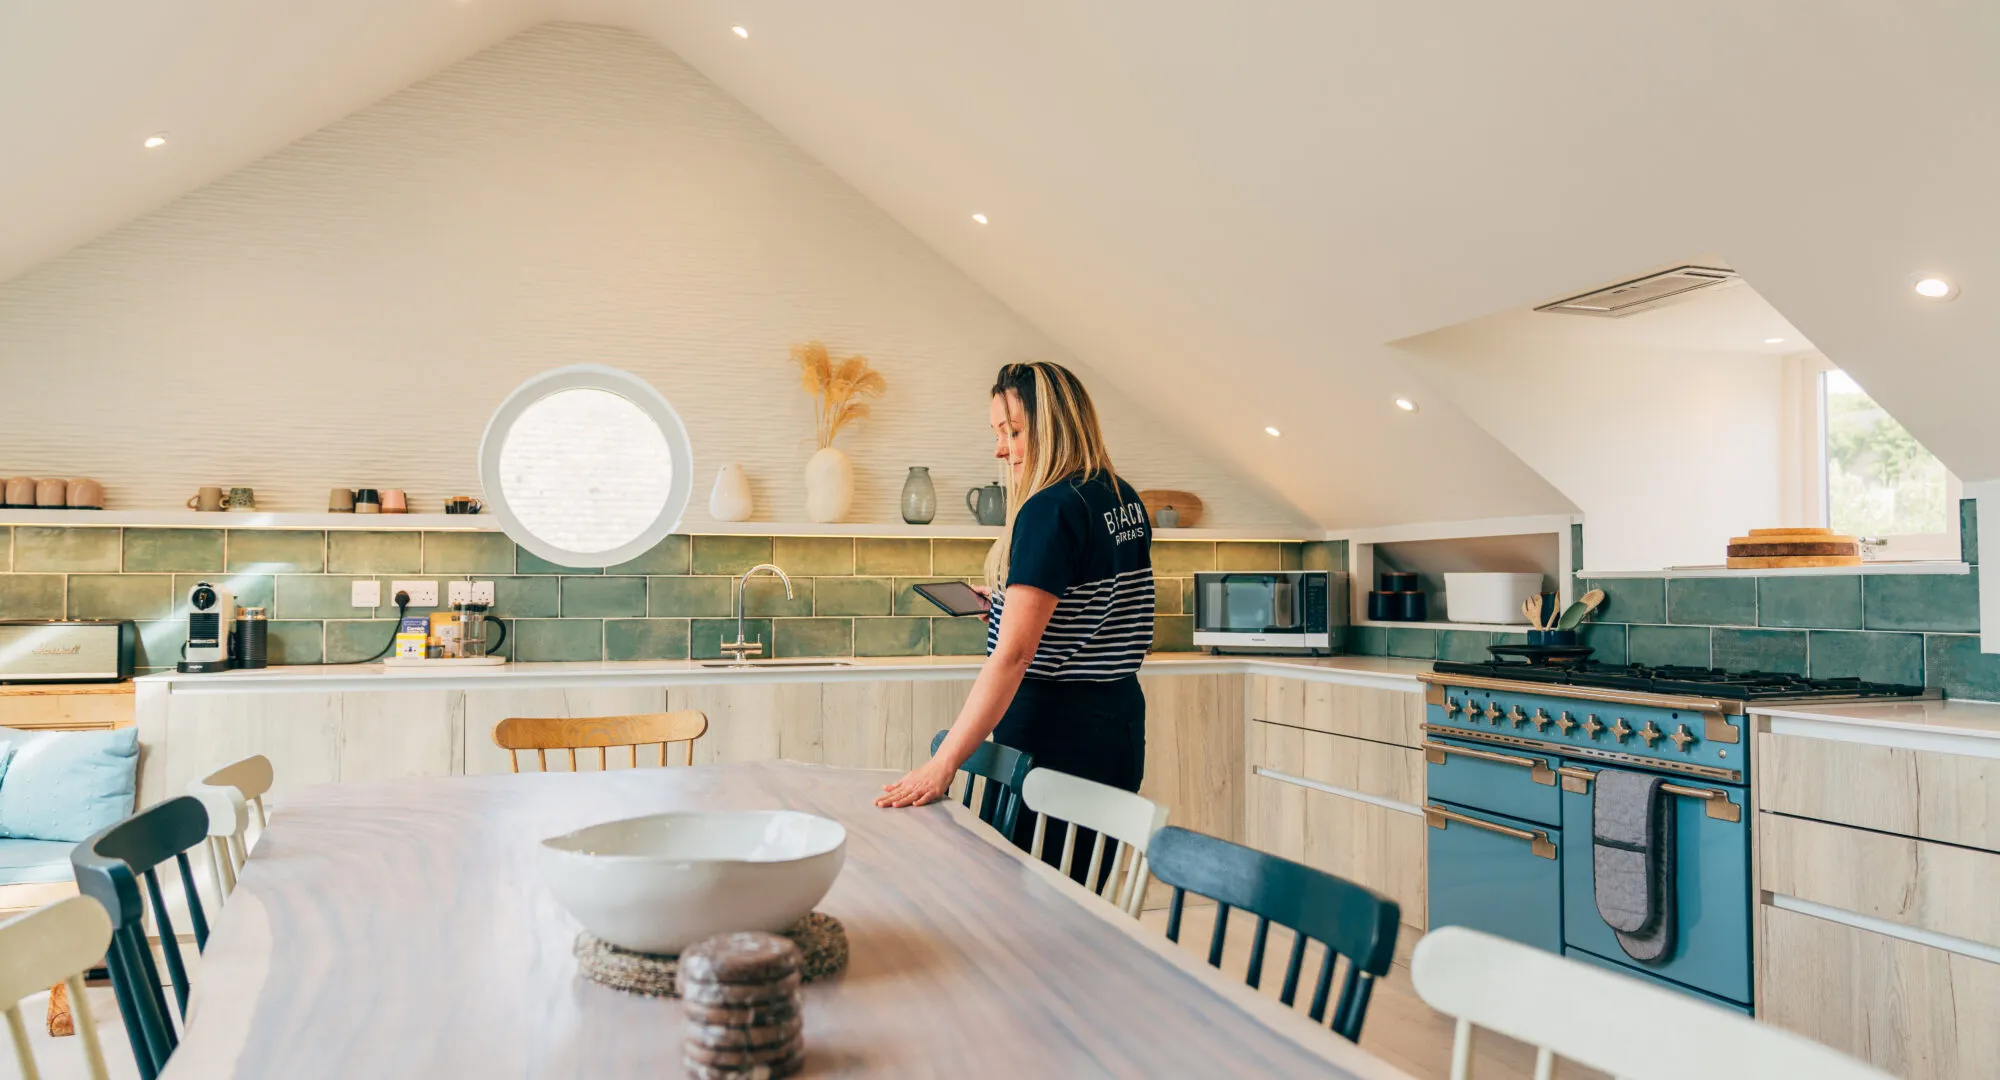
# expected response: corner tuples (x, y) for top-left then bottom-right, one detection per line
(70, 796), (208, 1080)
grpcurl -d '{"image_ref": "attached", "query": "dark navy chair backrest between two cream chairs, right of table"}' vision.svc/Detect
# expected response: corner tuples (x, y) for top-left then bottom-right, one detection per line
(1146, 826), (1402, 1040)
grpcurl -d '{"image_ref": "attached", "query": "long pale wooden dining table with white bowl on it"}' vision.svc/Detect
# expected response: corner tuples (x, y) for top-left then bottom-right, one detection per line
(164, 762), (1408, 1080)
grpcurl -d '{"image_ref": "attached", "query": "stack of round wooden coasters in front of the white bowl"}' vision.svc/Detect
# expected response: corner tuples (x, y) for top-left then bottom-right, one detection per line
(680, 934), (806, 1080)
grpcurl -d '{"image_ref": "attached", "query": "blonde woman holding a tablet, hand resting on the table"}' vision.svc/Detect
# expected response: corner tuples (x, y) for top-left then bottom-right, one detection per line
(876, 362), (1154, 868)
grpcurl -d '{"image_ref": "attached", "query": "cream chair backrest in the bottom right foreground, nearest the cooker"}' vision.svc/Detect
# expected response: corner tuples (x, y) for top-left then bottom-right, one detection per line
(1410, 926), (1888, 1080)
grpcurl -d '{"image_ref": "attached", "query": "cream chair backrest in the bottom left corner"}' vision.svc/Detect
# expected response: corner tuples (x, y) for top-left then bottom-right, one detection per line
(0, 896), (112, 1080)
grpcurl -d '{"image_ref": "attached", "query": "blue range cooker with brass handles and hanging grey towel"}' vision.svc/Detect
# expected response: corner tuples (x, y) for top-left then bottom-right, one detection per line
(1422, 660), (1936, 1012)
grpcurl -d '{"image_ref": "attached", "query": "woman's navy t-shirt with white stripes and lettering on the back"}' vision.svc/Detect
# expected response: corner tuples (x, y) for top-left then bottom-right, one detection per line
(986, 472), (1152, 682)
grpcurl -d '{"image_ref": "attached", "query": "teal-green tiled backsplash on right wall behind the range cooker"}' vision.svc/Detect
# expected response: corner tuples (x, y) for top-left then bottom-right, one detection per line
(1348, 500), (2000, 702)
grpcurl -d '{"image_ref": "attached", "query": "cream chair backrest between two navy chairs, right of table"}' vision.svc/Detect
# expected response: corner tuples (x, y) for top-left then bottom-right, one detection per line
(1020, 768), (1166, 918)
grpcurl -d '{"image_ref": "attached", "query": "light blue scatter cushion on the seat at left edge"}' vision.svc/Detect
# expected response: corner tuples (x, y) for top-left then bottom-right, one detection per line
(0, 728), (138, 844)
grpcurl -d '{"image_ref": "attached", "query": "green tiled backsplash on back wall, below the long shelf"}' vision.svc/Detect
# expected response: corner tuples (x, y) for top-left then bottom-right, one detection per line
(0, 526), (1312, 672)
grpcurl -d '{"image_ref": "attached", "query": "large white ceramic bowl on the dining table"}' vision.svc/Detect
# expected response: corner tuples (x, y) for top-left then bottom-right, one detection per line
(542, 810), (848, 954)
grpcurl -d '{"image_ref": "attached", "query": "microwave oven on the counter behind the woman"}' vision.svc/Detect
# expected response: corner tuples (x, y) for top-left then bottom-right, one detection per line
(1194, 570), (1346, 656)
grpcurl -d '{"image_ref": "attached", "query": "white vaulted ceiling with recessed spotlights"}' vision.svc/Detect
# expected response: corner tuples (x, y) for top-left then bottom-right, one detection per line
(0, 0), (2000, 526)
